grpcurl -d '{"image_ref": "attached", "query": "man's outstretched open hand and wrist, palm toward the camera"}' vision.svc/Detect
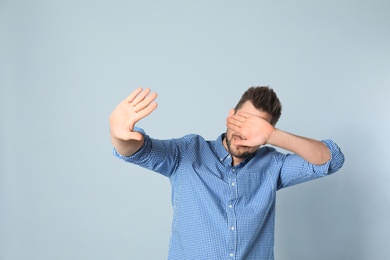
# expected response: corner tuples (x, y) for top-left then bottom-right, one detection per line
(110, 88), (157, 156)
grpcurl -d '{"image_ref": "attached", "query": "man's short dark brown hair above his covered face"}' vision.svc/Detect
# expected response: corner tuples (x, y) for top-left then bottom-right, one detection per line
(234, 86), (282, 125)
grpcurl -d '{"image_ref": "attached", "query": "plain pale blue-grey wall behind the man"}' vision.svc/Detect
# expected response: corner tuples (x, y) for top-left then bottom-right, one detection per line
(0, 0), (390, 260)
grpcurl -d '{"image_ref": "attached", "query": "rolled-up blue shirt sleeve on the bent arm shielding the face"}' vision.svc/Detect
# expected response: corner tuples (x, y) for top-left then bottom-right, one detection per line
(277, 140), (345, 189)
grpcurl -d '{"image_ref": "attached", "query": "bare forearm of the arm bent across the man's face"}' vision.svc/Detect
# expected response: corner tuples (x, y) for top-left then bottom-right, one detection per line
(267, 128), (331, 165)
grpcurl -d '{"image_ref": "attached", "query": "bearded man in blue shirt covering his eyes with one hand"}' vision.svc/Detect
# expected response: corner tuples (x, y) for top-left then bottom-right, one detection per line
(110, 87), (344, 260)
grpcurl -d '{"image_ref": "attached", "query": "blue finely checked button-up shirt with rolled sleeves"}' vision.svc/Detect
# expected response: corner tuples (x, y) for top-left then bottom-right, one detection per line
(114, 128), (344, 260)
